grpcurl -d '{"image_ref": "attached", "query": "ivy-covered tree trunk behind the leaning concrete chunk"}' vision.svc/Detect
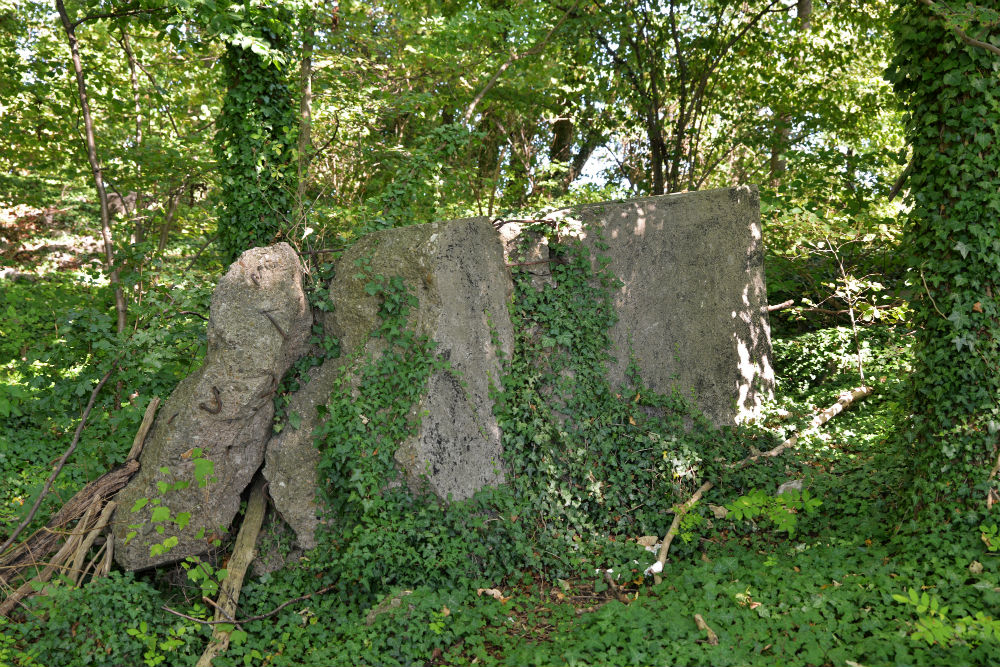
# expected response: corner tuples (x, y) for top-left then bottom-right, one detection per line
(215, 31), (298, 261)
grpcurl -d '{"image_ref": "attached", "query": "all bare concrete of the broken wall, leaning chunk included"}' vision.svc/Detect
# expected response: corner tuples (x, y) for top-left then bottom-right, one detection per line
(114, 188), (773, 569)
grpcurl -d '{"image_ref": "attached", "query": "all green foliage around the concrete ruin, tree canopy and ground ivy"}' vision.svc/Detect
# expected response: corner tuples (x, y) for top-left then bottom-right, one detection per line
(7, 0), (1000, 665)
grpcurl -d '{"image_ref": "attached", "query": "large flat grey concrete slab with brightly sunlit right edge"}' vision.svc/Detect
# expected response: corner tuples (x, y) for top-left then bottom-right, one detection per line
(568, 187), (774, 425)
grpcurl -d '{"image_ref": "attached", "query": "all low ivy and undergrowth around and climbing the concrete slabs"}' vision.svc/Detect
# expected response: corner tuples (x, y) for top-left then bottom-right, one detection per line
(0, 201), (1000, 665)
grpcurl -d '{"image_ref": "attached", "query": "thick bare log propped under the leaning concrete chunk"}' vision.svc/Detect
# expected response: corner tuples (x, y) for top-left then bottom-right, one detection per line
(197, 479), (267, 667)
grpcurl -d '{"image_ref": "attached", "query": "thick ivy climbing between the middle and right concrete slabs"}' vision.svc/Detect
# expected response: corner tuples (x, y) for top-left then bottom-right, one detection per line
(495, 222), (740, 552)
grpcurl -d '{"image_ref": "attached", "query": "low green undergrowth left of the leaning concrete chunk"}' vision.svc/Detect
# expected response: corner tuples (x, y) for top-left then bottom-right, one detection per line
(0, 263), (211, 522)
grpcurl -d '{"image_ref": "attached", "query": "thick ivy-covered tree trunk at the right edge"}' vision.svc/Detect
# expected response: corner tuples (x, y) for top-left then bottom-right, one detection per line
(890, 0), (1000, 504)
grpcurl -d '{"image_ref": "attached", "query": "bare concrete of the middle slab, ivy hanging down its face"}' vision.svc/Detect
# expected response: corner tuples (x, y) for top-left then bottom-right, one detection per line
(264, 218), (514, 548)
